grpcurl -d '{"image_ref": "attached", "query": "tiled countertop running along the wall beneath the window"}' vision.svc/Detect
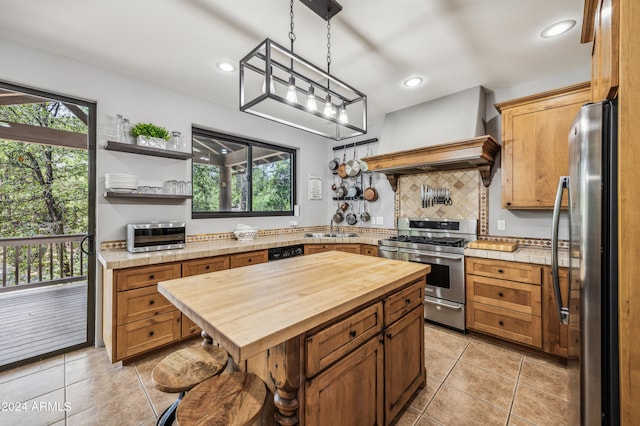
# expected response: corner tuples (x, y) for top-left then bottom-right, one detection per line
(98, 232), (389, 269)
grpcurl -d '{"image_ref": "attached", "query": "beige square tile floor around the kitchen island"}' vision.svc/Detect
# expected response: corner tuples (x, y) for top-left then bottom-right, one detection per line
(0, 324), (567, 426)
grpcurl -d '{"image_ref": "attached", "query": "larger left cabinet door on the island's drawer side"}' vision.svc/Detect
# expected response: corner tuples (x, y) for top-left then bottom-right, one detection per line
(305, 335), (384, 426)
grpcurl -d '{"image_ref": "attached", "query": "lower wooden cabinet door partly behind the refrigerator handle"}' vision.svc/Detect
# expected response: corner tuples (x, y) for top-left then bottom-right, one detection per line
(542, 267), (574, 357)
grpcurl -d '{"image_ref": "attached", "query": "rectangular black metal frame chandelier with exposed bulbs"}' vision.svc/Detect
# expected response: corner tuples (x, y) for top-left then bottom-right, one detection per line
(240, 0), (367, 140)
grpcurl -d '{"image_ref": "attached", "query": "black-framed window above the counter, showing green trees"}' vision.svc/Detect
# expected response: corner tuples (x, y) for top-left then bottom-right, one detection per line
(191, 128), (296, 219)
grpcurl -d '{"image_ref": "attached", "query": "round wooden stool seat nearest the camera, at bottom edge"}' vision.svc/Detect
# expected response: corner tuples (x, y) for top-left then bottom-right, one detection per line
(176, 372), (267, 426)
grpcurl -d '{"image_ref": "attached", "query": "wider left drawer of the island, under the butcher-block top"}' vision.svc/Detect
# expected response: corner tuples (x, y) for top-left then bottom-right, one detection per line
(306, 302), (382, 377)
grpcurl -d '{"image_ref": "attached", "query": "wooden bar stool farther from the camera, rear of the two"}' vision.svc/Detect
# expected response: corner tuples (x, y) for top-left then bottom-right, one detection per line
(151, 342), (229, 426)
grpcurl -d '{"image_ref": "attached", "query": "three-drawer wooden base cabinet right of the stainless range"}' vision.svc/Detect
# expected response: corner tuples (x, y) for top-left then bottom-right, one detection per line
(465, 257), (542, 348)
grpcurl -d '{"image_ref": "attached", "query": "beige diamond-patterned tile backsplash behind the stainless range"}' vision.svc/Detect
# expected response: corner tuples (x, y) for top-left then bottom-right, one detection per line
(396, 169), (486, 221)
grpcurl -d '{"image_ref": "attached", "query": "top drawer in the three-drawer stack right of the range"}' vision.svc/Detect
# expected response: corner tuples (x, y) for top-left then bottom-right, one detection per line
(465, 257), (542, 285)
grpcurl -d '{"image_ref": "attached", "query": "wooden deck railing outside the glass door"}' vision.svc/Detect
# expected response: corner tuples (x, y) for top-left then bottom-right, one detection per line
(0, 234), (88, 291)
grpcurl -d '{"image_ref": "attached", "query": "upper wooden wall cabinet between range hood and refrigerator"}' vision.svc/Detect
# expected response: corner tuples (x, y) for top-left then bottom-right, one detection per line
(496, 82), (591, 209)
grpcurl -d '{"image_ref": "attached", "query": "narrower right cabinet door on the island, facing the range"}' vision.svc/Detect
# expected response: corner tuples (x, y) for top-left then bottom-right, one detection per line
(384, 306), (426, 423)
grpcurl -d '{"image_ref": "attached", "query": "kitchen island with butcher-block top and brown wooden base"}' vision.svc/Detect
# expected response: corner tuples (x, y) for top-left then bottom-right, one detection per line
(158, 251), (430, 425)
